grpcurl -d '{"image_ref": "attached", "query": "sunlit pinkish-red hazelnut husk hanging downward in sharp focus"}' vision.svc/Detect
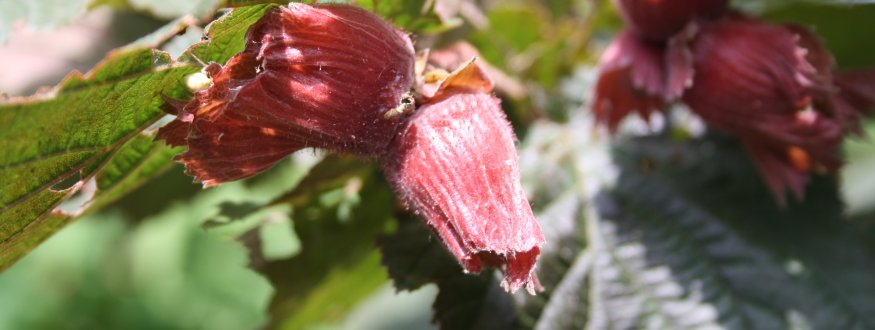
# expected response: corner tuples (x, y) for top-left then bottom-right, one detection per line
(383, 63), (544, 294)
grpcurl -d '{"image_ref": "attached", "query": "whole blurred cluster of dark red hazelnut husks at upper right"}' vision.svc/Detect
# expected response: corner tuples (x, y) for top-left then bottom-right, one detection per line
(593, 0), (875, 204)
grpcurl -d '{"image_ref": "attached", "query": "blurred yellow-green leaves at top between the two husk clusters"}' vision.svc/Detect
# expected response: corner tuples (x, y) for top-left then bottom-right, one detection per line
(467, 1), (600, 122)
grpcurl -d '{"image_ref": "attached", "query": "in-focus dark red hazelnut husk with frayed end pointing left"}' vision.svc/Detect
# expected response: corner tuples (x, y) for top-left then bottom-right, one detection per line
(159, 3), (414, 186)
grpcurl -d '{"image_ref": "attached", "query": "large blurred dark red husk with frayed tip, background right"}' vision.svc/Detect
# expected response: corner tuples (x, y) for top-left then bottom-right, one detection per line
(683, 16), (866, 202)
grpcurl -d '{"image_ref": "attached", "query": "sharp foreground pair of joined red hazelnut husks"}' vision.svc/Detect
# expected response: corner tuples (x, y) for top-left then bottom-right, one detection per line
(158, 3), (544, 293)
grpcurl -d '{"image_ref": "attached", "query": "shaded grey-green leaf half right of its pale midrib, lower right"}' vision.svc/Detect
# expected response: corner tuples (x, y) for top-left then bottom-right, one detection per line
(591, 138), (875, 329)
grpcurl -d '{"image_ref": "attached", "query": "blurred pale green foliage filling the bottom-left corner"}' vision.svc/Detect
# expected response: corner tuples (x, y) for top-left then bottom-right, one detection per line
(0, 196), (273, 330)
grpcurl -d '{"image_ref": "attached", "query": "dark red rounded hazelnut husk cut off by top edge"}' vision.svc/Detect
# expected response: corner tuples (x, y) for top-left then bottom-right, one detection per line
(614, 0), (729, 41)
